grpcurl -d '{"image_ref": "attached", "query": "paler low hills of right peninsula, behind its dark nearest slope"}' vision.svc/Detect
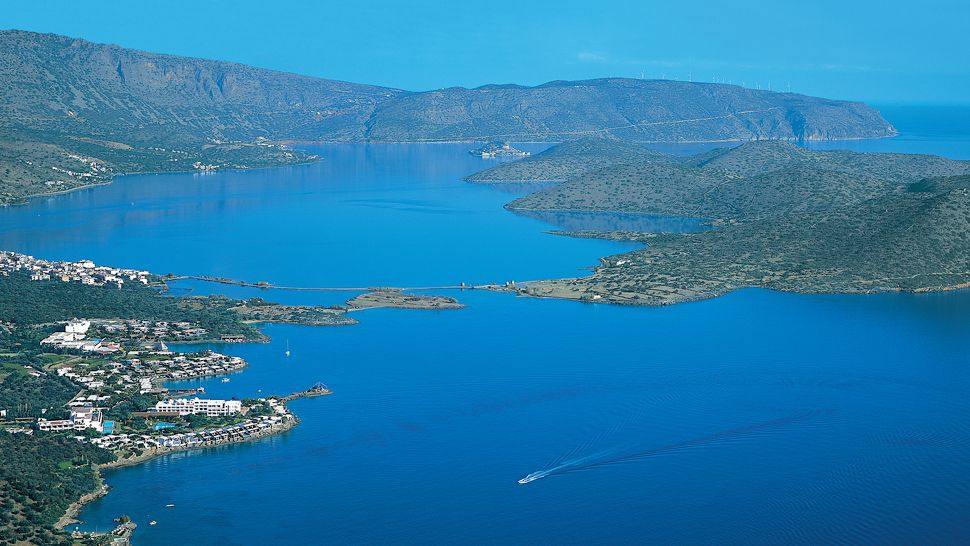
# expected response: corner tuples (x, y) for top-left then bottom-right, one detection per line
(503, 141), (970, 221)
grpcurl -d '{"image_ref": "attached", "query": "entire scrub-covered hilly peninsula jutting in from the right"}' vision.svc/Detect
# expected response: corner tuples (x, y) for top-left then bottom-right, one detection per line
(469, 141), (970, 305)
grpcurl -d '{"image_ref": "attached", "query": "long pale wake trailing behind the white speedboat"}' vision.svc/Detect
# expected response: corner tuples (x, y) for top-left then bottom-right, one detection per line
(519, 410), (822, 485)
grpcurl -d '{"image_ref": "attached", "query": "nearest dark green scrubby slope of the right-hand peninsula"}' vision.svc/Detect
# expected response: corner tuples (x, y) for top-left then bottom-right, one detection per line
(524, 177), (970, 305)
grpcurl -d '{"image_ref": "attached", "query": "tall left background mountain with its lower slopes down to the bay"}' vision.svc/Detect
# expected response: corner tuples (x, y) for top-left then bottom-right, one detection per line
(0, 31), (395, 204)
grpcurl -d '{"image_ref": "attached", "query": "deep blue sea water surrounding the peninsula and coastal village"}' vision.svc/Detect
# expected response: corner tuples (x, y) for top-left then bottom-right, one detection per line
(0, 105), (970, 545)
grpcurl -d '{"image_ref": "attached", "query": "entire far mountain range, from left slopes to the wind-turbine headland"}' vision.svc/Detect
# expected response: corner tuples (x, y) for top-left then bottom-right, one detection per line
(0, 30), (895, 204)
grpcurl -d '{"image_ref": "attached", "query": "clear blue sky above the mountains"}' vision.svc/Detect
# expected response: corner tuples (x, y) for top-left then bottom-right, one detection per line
(0, 0), (970, 104)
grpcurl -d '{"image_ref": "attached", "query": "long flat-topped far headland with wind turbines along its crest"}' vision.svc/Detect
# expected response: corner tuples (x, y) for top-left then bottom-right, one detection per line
(367, 78), (896, 142)
